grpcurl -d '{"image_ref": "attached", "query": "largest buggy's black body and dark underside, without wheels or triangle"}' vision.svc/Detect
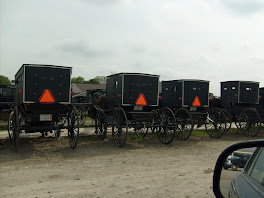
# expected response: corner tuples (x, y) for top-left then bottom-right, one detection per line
(15, 64), (72, 132)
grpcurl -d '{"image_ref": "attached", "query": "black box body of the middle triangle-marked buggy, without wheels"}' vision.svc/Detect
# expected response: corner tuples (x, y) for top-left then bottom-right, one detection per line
(106, 73), (159, 107)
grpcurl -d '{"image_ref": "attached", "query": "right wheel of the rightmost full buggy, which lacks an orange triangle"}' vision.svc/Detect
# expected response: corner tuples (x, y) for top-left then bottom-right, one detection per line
(238, 108), (261, 137)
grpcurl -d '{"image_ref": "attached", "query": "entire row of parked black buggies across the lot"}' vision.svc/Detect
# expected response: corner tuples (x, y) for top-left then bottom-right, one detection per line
(0, 64), (264, 150)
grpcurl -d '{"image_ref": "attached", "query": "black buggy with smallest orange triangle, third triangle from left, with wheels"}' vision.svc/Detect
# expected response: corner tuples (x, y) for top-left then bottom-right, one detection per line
(162, 79), (226, 140)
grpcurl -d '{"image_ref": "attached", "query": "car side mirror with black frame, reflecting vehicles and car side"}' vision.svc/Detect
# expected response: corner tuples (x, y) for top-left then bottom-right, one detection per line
(213, 140), (264, 198)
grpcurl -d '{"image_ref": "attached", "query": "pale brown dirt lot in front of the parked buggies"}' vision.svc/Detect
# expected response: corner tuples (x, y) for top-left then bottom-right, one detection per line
(0, 129), (263, 198)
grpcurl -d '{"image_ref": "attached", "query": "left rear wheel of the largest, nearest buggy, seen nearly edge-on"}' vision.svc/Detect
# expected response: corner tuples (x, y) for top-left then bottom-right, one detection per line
(8, 108), (20, 151)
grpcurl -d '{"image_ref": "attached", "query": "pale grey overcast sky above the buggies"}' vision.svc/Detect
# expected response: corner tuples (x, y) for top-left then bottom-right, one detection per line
(0, 0), (264, 95)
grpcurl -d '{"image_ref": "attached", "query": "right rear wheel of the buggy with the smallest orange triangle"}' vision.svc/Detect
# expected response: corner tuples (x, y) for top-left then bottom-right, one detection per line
(205, 108), (226, 138)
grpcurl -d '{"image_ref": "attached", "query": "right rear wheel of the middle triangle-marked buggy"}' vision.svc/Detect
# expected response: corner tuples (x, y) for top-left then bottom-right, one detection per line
(154, 107), (177, 144)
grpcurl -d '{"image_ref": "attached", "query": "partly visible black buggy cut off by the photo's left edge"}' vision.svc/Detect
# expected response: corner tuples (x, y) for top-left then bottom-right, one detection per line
(0, 85), (15, 121)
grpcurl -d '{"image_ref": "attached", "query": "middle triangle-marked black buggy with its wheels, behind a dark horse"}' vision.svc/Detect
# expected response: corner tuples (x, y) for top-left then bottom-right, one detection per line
(93, 73), (176, 147)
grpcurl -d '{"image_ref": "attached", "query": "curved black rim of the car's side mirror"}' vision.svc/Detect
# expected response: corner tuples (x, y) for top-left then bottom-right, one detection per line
(213, 140), (264, 198)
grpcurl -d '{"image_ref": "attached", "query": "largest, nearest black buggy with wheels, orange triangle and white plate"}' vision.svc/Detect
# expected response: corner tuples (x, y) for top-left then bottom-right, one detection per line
(8, 64), (79, 150)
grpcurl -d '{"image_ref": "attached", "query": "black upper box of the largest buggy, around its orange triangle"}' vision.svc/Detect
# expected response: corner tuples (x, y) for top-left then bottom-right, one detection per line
(15, 64), (72, 104)
